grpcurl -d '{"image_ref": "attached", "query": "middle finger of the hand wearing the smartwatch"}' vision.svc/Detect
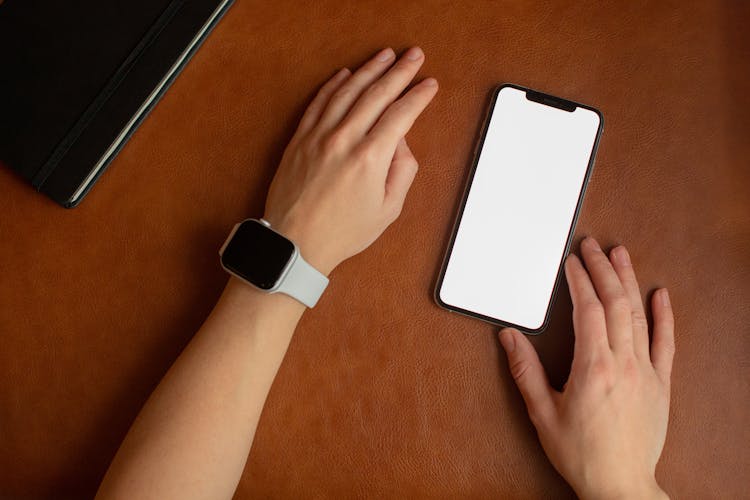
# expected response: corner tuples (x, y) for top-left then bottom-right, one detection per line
(345, 47), (424, 135)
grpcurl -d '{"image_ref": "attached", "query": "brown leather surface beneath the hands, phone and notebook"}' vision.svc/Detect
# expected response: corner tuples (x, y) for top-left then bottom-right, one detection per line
(0, 0), (750, 498)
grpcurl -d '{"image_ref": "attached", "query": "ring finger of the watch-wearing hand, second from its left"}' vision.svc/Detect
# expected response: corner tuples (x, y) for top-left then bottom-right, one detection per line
(319, 48), (396, 133)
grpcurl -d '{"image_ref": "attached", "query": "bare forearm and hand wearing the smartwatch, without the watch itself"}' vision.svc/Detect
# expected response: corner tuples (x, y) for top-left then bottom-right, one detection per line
(97, 48), (437, 499)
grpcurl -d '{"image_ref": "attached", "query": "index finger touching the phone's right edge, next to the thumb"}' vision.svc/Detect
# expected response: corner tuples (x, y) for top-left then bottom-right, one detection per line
(565, 254), (610, 364)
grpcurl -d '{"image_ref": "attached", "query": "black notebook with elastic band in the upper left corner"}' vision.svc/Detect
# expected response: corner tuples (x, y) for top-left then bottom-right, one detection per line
(0, 0), (232, 207)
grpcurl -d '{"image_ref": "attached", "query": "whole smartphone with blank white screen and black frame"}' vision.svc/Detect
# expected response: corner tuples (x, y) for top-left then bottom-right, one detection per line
(435, 84), (604, 335)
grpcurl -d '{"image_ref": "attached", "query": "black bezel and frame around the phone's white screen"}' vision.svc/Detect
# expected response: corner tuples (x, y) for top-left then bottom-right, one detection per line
(433, 83), (604, 335)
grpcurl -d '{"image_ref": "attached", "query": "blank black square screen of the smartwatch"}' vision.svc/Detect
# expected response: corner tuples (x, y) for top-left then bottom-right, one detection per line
(221, 220), (294, 290)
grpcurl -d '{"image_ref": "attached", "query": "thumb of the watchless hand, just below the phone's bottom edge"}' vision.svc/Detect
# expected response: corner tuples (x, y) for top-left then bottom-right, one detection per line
(500, 328), (554, 425)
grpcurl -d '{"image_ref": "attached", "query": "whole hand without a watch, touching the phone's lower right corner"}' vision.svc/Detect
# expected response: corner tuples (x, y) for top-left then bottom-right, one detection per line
(500, 238), (675, 499)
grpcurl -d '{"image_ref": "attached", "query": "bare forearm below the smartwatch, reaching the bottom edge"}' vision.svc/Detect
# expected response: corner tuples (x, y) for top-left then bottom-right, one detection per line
(98, 278), (305, 498)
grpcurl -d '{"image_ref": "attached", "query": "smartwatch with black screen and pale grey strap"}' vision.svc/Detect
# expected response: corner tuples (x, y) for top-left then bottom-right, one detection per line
(219, 219), (328, 307)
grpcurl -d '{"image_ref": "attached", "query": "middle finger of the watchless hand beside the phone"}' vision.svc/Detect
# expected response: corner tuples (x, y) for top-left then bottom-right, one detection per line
(581, 237), (633, 354)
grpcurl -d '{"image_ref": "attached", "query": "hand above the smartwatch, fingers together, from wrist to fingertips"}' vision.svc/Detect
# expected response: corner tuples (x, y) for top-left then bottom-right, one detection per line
(264, 47), (437, 274)
